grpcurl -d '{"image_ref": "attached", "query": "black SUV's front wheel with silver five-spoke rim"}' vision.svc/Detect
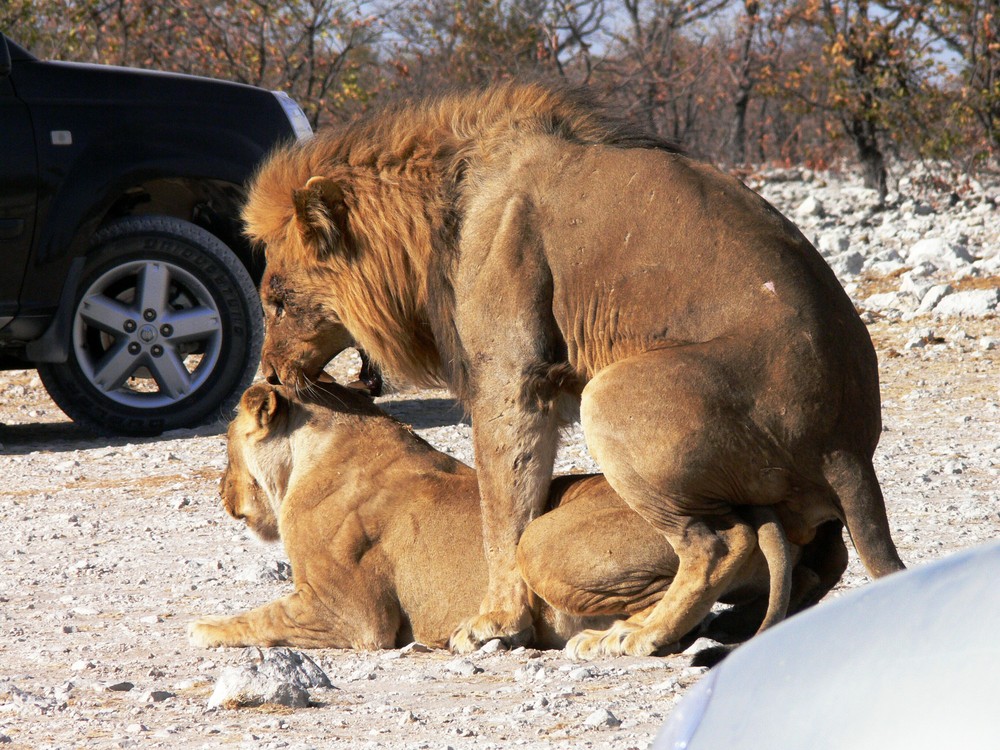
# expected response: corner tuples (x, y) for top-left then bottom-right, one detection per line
(38, 215), (264, 436)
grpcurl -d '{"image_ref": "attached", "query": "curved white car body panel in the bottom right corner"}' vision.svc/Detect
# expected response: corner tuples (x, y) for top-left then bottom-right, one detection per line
(653, 544), (1000, 750)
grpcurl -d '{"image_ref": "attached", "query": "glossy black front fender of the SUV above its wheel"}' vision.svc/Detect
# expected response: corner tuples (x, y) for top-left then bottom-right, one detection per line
(0, 33), (294, 346)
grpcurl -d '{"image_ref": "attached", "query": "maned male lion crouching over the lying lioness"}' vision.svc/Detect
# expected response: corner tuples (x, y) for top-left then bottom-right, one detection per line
(244, 84), (903, 655)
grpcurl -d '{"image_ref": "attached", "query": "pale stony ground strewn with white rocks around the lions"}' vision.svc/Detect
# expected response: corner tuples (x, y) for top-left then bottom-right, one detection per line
(0, 166), (1000, 750)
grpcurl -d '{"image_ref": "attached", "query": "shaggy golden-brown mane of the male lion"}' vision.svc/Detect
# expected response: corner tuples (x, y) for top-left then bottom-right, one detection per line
(244, 83), (678, 394)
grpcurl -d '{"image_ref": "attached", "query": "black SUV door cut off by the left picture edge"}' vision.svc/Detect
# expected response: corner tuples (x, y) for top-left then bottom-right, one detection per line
(0, 35), (38, 328)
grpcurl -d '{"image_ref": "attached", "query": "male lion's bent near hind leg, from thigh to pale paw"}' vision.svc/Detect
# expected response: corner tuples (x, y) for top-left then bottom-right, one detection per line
(567, 345), (775, 656)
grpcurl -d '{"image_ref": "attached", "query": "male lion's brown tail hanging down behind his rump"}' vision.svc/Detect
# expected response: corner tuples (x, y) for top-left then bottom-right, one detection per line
(823, 451), (906, 578)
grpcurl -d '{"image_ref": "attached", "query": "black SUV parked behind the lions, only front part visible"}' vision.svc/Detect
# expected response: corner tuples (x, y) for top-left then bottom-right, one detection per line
(0, 34), (311, 435)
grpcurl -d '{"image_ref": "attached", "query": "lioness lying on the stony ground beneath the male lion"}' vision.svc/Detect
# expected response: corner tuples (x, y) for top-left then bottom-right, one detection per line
(190, 383), (846, 649)
